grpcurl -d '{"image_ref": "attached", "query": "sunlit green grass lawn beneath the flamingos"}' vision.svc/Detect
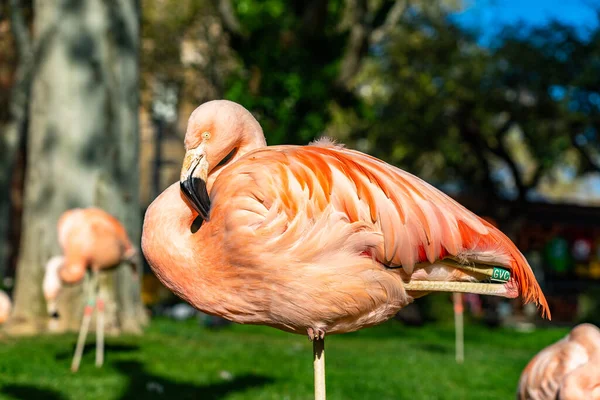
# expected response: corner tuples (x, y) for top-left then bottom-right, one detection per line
(0, 320), (567, 400)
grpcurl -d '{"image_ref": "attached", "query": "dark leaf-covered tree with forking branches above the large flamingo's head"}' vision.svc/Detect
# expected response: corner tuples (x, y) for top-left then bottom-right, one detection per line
(218, 0), (460, 144)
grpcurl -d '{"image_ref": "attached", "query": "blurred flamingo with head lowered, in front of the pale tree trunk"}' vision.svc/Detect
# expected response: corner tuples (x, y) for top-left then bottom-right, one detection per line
(42, 207), (138, 372)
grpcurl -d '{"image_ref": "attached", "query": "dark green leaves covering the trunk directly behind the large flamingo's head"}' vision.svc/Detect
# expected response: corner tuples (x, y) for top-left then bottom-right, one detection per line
(226, 0), (346, 144)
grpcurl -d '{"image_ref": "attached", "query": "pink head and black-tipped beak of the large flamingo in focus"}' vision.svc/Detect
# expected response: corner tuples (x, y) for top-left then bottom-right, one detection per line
(179, 100), (266, 220)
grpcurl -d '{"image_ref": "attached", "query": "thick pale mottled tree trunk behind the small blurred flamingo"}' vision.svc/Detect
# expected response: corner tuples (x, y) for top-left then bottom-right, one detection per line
(7, 0), (146, 334)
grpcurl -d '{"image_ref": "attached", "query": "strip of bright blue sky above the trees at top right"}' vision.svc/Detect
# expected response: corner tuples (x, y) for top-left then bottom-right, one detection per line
(455, 0), (600, 43)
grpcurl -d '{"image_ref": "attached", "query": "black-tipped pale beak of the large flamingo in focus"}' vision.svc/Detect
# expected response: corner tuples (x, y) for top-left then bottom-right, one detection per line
(179, 146), (210, 221)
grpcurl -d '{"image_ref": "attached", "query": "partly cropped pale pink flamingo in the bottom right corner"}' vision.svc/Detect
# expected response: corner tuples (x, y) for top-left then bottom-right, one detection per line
(517, 324), (600, 400)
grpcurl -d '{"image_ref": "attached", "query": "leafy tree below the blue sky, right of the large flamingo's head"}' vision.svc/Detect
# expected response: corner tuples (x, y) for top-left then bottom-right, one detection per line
(332, 10), (600, 220)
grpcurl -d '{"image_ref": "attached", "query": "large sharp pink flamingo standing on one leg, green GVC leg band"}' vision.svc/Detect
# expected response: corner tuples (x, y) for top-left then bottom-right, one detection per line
(142, 100), (550, 399)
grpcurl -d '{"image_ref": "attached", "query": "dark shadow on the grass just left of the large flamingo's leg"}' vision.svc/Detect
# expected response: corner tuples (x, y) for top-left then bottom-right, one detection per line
(113, 361), (274, 400)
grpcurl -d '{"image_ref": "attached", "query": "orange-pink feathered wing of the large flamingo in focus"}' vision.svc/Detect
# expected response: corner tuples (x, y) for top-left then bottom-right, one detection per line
(211, 143), (547, 313)
